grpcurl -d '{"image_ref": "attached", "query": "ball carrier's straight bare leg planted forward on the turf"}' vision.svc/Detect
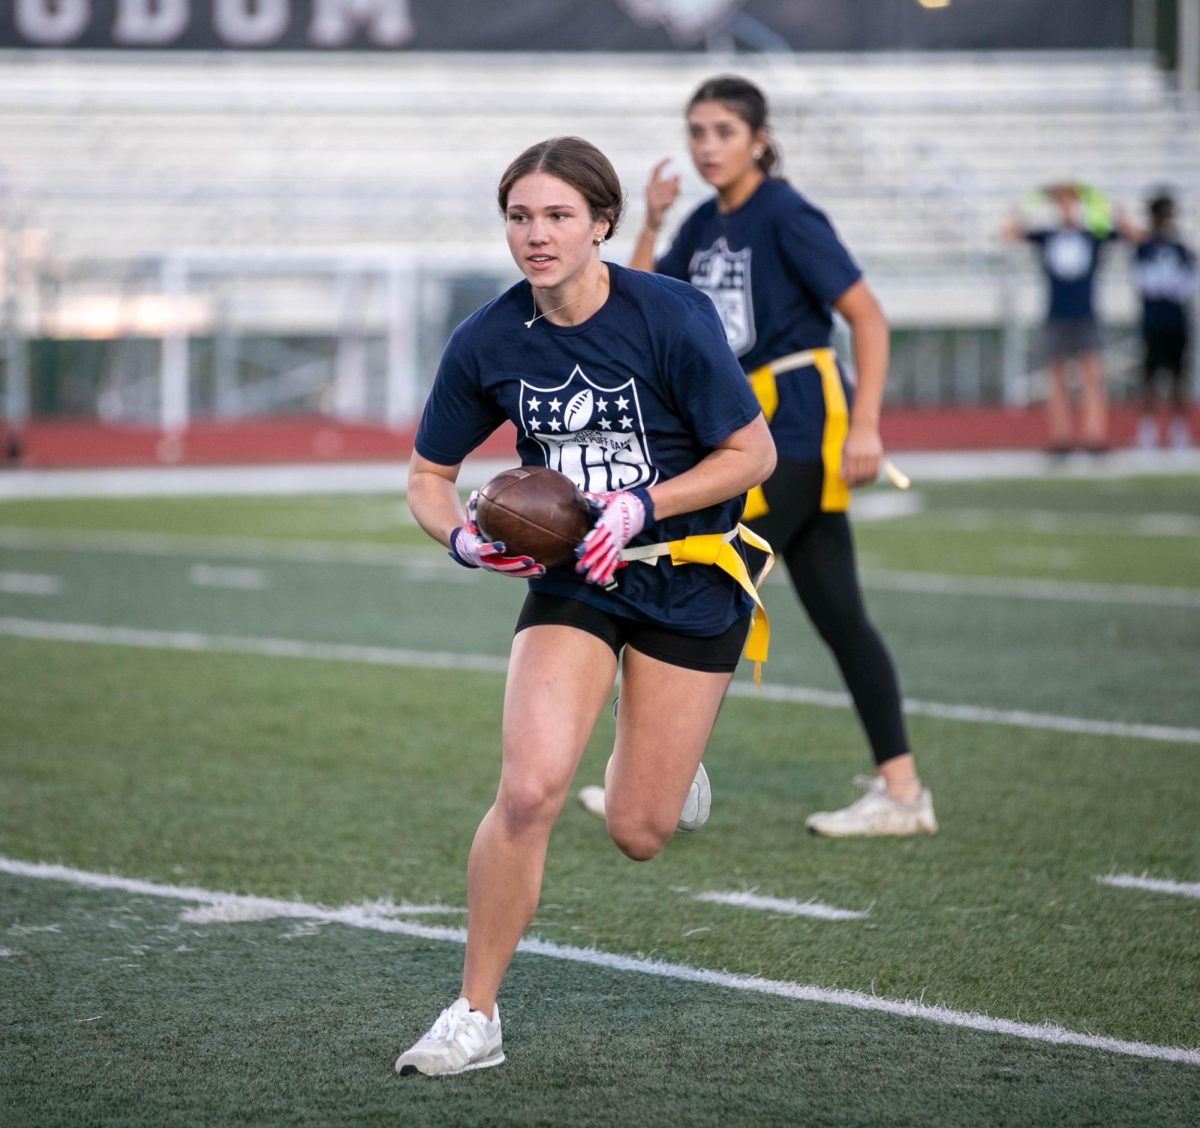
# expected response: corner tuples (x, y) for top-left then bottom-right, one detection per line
(462, 626), (614, 1014)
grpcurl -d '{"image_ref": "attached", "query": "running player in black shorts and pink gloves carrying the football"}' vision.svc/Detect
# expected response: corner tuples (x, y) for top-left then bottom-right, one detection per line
(396, 137), (775, 1074)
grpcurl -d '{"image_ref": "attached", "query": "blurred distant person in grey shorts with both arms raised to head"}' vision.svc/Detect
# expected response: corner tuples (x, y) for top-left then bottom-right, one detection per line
(1004, 184), (1124, 455)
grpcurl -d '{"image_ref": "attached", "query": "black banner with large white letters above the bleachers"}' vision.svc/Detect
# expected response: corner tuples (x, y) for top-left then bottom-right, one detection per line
(0, 0), (1132, 52)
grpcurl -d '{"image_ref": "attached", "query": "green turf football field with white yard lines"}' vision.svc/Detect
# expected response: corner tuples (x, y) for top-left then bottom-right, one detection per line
(0, 476), (1200, 1126)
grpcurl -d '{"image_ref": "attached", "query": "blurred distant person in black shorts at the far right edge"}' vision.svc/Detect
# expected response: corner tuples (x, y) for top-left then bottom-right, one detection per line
(1135, 194), (1196, 450)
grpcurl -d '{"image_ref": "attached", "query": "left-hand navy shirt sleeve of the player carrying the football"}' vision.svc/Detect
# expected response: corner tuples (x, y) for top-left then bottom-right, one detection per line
(413, 326), (504, 466)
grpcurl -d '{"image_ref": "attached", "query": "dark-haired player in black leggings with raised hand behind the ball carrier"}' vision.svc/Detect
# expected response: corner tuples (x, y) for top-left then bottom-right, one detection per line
(580, 76), (937, 836)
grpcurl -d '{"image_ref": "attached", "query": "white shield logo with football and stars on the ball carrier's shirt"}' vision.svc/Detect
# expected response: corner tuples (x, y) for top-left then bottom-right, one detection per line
(521, 365), (659, 493)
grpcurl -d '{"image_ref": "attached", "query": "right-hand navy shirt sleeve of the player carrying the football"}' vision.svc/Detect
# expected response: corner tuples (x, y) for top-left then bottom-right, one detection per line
(668, 292), (760, 446)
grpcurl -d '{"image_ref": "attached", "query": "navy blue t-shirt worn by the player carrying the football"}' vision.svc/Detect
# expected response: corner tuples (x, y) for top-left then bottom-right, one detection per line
(415, 263), (758, 635)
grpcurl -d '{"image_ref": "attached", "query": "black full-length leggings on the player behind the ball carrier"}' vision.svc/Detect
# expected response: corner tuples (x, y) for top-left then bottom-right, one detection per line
(750, 460), (908, 764)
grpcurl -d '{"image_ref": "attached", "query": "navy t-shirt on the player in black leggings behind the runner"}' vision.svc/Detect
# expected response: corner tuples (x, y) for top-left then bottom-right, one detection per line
(654, 179), (863, 461)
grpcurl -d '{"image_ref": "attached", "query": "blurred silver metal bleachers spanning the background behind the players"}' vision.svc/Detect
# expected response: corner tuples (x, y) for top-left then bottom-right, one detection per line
(0, 52), (1200, 419)
